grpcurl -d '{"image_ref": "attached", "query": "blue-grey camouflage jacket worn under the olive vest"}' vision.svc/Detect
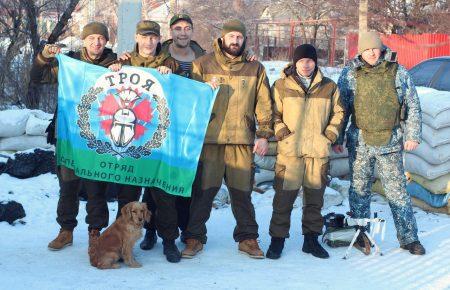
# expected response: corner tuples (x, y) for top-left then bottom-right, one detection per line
(336, 48), (422, 154)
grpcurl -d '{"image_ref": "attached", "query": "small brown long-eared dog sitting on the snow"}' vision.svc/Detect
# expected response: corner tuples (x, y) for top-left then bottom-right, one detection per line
(89, 201), (151, 269)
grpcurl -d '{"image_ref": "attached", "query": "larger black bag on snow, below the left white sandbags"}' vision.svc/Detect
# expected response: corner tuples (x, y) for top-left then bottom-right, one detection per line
(5, 149), (56, 178)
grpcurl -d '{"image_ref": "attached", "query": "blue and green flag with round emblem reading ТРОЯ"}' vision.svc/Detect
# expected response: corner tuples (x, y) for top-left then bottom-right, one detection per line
(56, 55), (217, 196)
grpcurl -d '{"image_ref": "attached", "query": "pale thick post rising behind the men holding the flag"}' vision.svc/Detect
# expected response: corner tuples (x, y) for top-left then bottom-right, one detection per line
(117, 0), (142, 54)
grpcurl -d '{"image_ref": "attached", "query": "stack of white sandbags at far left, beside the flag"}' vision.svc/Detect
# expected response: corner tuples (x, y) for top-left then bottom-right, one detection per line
(0, 109), (52, 152)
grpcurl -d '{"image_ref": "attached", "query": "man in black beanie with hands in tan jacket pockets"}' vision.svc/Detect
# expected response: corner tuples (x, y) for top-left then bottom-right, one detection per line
(266, 44), (344, 259)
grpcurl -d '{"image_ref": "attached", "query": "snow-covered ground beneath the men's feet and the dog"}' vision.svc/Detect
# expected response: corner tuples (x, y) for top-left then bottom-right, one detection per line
(0, 174), (450, 290)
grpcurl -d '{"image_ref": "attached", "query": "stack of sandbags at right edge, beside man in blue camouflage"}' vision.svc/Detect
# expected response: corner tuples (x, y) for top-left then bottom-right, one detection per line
(405, 87), (450, 214)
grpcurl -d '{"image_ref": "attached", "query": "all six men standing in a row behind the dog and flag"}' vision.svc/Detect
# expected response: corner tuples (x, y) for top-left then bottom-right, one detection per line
(31, 14), (425, 263)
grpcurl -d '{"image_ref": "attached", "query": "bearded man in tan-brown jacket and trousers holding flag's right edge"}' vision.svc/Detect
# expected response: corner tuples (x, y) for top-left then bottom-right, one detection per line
(182, 20), (273, 258)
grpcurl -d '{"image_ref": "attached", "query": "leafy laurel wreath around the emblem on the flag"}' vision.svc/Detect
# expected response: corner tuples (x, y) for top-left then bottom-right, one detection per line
(77, 87), (170, 159)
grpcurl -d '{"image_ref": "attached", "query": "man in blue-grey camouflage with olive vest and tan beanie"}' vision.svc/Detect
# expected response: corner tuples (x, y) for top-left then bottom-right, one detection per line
(334, 32), (425, 255)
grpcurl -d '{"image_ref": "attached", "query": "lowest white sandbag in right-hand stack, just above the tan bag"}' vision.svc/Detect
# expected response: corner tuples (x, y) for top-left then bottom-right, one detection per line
(405, 152), (450, 179)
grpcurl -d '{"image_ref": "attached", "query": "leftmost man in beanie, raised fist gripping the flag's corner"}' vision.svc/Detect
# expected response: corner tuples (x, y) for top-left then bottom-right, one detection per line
(30, 22), (117, 251)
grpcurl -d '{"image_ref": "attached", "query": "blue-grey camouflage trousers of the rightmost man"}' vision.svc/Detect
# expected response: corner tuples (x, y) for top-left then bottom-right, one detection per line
(349, 145), (418, 245)
